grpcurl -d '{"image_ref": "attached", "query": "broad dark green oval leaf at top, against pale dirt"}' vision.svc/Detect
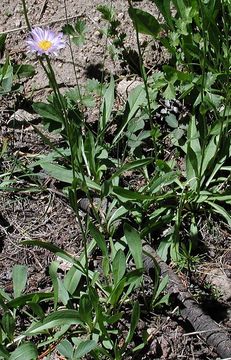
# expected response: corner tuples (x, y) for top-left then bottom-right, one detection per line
(128, 7), (161, 37)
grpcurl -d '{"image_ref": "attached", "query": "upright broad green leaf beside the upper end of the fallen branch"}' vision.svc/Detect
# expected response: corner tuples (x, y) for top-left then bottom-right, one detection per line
(124, 223), (143, 269)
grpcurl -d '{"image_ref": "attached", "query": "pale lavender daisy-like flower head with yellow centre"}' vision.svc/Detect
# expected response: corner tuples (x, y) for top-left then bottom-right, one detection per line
(26, 27), (66, 56)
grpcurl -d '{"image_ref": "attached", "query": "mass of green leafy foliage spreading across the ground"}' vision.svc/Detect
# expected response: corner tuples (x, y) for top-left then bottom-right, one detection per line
(0, 0), (231, 360)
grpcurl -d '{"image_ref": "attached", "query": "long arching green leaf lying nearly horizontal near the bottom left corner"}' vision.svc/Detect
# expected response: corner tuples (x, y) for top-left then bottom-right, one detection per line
(25, 309), (82, 336)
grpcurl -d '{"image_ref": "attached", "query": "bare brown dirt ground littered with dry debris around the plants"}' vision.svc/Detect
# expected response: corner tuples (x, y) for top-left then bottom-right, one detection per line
(0, 0), (231, 360)
